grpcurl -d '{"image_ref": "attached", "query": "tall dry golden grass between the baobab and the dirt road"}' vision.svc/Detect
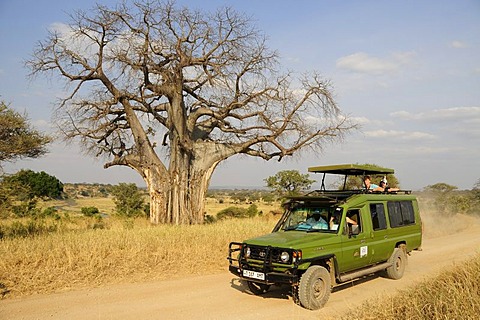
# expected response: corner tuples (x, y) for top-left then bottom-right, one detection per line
(0, 215), (276, 298)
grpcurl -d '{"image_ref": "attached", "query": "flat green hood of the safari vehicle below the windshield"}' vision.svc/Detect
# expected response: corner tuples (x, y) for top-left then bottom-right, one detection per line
(244, 231), (338, 249)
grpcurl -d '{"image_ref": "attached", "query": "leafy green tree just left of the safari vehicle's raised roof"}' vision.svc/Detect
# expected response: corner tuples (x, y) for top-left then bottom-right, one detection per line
(264, 170), (315, 196)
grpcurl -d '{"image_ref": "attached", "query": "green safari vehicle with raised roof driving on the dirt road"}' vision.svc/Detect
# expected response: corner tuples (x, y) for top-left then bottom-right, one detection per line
(228, 164), (422, 310)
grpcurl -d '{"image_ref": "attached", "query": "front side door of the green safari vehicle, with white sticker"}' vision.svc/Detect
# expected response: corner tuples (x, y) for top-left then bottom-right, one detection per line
(337, 208), (370, 272)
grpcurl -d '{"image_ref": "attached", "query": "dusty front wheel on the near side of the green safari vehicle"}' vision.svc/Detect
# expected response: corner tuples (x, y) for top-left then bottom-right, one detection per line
(298, 266), (332, 310)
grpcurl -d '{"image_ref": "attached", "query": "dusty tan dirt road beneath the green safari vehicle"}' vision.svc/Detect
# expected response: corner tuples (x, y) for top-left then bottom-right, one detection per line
(0, 215), (480, 320)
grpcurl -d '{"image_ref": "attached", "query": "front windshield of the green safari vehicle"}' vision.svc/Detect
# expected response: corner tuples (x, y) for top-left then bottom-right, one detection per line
(280, 204), (342, 232)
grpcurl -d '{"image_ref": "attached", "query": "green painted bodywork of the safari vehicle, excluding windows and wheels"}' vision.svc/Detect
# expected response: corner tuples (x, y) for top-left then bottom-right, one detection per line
(244, 194), (422, 274)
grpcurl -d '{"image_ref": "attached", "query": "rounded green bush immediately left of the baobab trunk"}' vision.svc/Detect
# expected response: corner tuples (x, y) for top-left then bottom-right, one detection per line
(112, 183), (145, 217)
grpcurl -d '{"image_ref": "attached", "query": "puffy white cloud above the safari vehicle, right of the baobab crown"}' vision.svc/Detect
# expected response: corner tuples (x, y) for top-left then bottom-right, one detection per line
(336, 52), (415, 75)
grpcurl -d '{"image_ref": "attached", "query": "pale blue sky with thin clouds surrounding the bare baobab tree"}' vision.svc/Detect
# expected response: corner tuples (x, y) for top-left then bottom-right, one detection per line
(0, 0), (480, 190)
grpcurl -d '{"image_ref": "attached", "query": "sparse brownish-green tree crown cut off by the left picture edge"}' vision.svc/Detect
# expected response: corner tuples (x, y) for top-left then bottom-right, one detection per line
(0, 101), (51, 166)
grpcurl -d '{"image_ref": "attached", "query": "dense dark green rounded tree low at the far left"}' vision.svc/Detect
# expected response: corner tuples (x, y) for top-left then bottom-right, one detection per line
(3, 170), (63, 199)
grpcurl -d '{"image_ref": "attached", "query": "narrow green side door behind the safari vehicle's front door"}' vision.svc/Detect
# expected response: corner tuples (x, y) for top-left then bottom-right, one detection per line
(367, 202), (392, 263)
